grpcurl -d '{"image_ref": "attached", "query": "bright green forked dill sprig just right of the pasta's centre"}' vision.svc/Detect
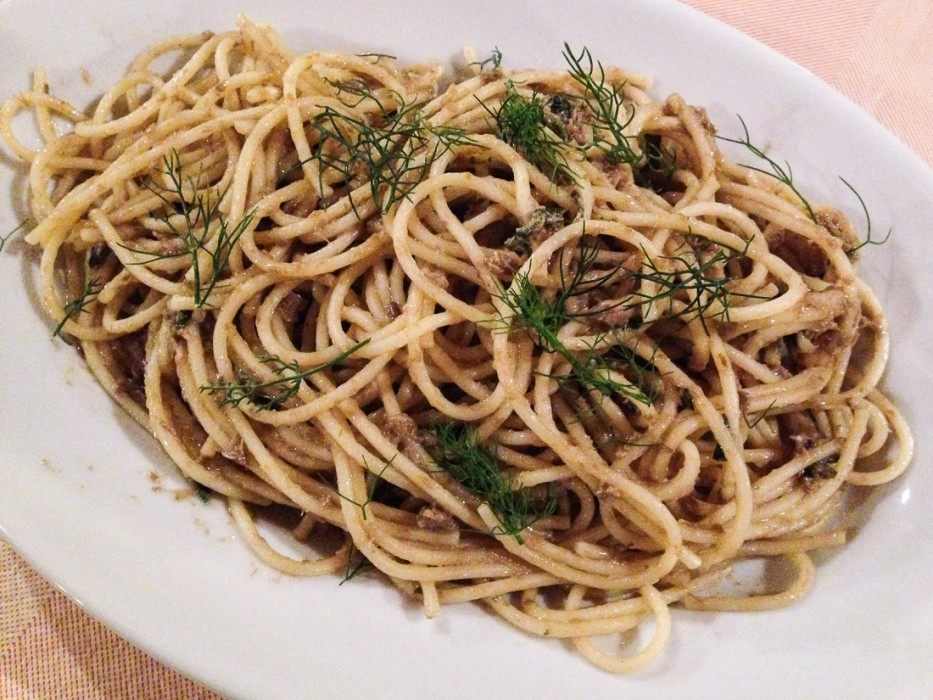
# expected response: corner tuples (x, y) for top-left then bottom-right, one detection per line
(499, 240), (652, 405)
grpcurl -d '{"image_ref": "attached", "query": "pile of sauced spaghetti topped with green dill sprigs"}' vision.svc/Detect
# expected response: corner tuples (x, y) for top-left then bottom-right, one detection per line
(0, 20), (912, 672)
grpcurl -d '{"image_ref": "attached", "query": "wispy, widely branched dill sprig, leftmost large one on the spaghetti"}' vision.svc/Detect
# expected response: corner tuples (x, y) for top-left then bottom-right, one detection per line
(122, 149), (255, 308)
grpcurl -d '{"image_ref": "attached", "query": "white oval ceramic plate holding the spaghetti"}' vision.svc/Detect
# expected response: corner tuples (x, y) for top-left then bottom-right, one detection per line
(0, 0), (933, 700)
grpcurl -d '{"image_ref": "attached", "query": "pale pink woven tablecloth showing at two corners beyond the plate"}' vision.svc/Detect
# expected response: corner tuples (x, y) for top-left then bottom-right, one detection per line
(0, 0), (933, 700)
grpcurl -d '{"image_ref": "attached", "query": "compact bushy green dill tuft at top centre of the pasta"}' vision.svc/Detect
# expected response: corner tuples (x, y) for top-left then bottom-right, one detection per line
(476, 81), (576, 182)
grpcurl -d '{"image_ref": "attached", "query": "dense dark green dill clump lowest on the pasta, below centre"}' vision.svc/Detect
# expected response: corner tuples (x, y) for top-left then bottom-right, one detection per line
(431, 423), (557, 544)
